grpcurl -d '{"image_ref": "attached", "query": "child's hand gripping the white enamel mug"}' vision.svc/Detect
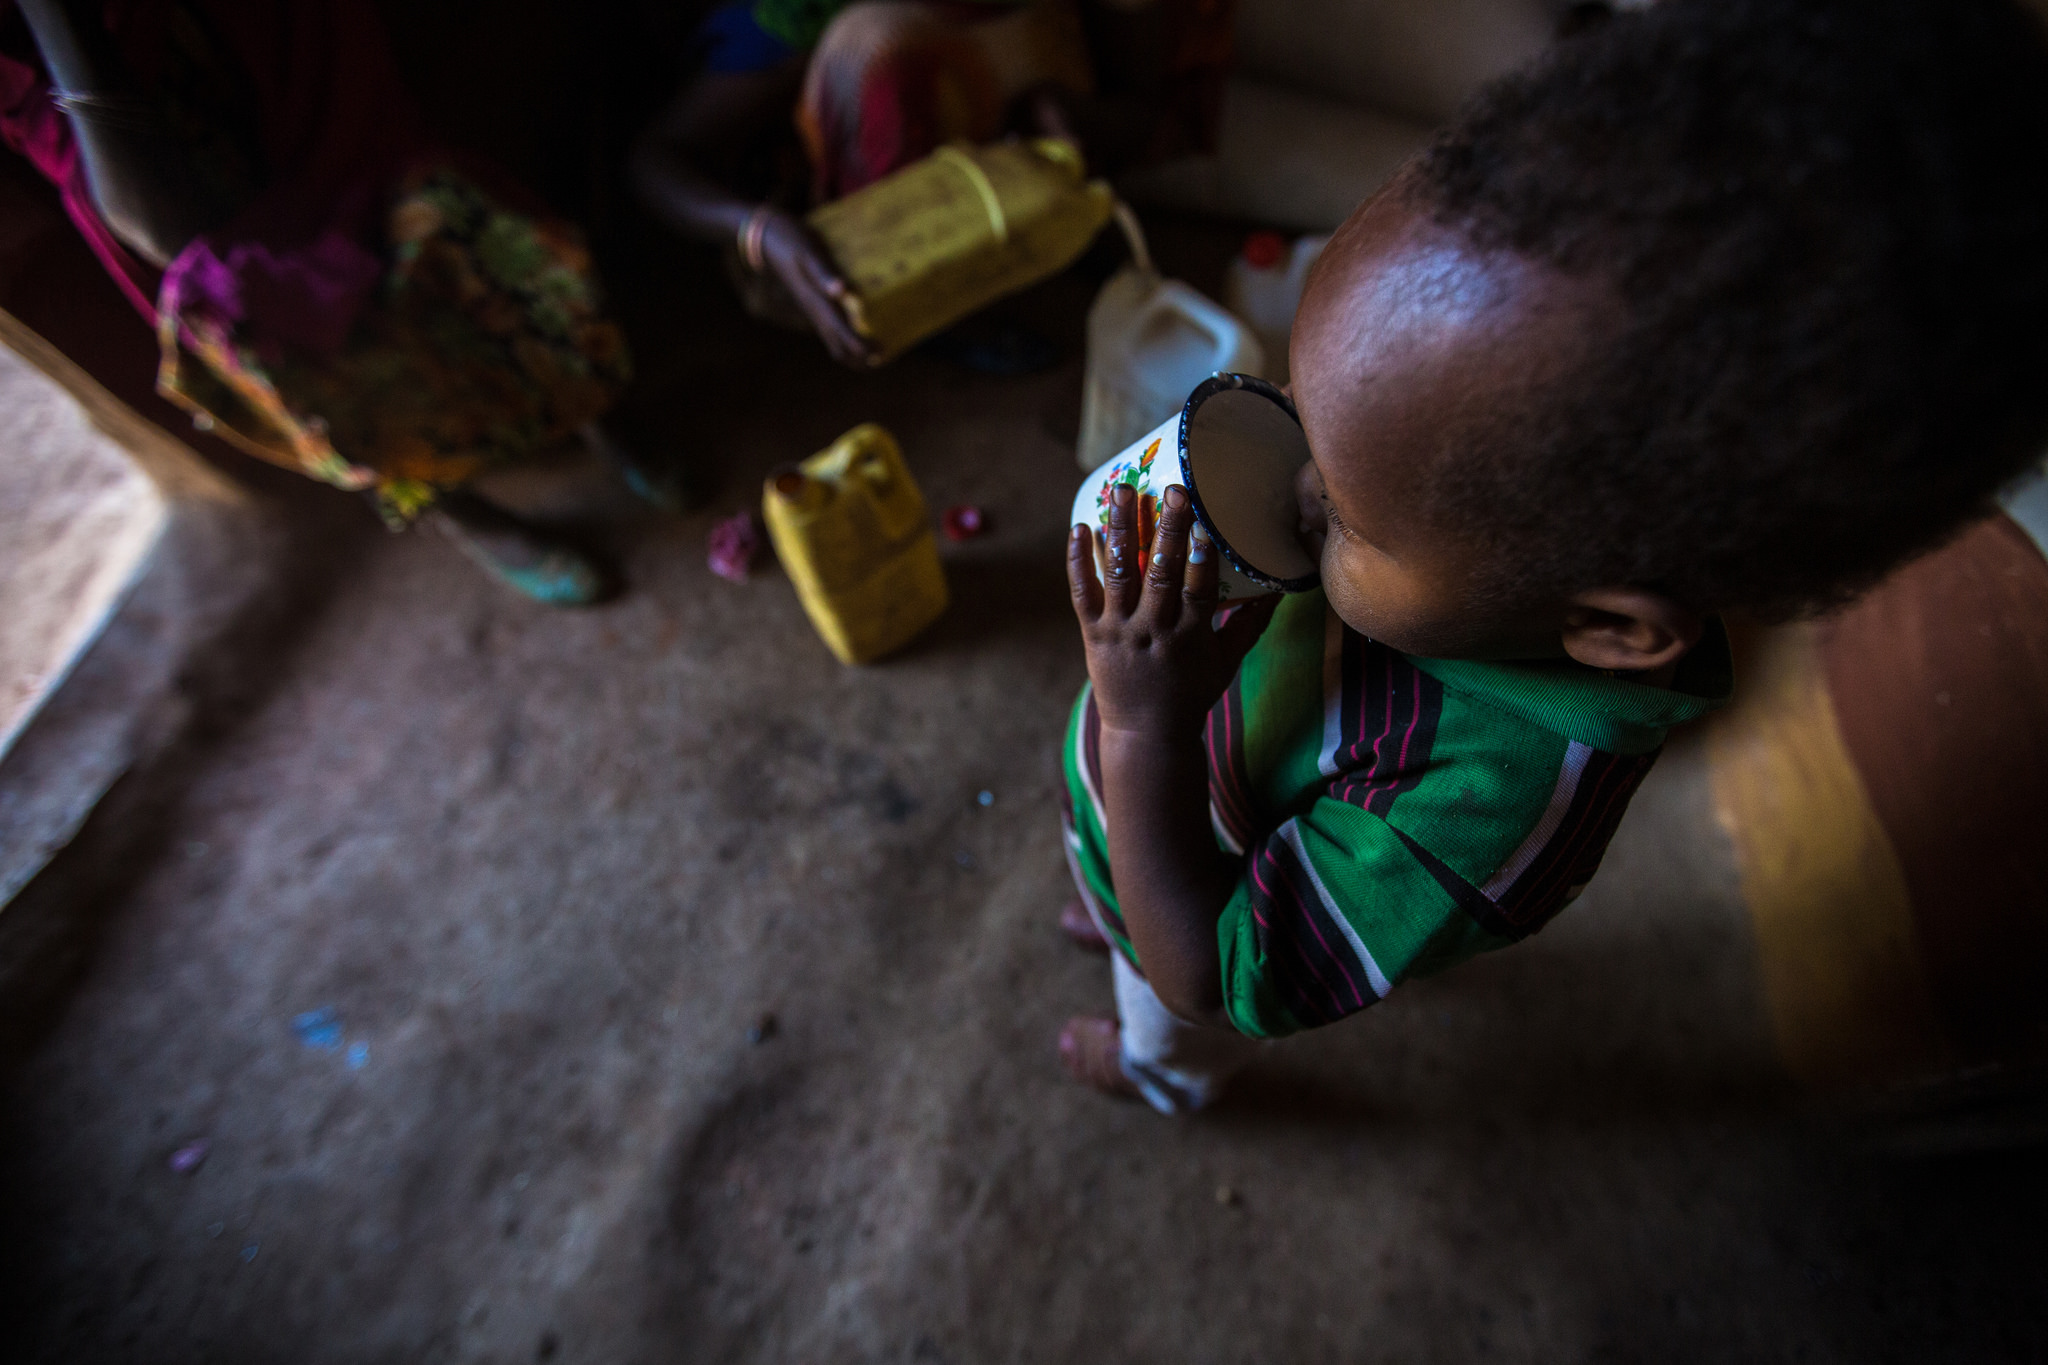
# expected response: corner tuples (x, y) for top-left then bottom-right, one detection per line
(1067, 483), (1278, 739)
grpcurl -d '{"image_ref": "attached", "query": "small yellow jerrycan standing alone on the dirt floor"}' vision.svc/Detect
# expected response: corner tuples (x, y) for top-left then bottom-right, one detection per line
(762, 422), (946, 663)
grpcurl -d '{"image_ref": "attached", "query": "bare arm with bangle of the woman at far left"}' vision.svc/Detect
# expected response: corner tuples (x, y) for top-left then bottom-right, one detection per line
(20, 0), (231, 268)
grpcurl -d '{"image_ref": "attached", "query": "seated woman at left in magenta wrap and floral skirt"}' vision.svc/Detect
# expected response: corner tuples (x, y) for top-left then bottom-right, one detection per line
(0, 0), (676, 604)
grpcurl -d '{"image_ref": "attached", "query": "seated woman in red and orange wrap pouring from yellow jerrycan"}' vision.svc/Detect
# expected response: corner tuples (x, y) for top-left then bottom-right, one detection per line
(633, 0), (1231, 366)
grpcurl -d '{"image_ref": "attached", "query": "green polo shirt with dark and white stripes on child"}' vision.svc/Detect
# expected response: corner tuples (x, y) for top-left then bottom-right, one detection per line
(1065, 591), (1731, 1038)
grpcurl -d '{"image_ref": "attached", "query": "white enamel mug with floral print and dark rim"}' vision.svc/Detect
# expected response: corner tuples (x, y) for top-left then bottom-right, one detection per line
(1069, 372), (1321, 602)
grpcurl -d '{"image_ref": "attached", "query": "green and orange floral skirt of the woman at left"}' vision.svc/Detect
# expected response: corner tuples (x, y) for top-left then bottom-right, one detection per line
(158, 170), (633, 526)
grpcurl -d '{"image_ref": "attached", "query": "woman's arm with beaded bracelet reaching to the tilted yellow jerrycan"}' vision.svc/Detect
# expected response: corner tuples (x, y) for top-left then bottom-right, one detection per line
(633, 57), (872, 368)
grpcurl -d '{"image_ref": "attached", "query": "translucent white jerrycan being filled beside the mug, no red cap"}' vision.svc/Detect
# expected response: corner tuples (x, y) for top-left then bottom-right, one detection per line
(1075, 205), (1266, 471)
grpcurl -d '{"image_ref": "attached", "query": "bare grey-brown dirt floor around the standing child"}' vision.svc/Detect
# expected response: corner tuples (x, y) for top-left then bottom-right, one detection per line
(0, 224), (2048, 1365)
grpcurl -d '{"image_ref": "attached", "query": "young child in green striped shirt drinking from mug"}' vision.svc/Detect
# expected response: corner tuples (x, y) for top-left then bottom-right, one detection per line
(1061, 0), (2048, 1111)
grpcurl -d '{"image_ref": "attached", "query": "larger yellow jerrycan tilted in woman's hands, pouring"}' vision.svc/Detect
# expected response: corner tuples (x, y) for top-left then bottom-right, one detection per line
(809, 137), (1116, 362)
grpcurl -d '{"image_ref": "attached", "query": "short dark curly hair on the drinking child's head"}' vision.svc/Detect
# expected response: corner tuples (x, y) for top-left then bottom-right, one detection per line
(1407, 0), (2048, 616)
